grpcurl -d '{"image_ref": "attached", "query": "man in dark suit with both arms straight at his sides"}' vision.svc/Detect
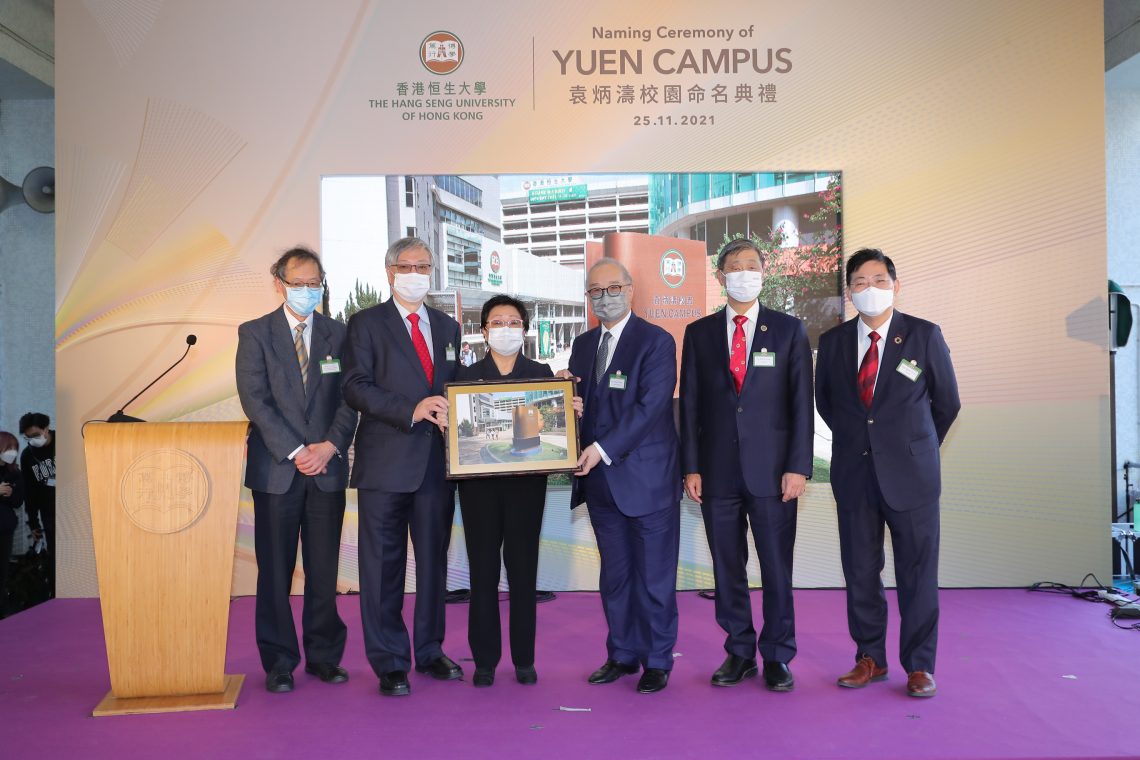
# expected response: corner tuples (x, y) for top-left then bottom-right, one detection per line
(681, 239), (815, 692)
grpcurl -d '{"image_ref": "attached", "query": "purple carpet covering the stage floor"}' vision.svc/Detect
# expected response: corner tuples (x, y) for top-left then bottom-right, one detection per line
(0, 590), (1140, 760)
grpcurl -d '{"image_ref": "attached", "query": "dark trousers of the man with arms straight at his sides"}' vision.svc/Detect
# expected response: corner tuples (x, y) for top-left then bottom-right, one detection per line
(701, 479), (797, 663)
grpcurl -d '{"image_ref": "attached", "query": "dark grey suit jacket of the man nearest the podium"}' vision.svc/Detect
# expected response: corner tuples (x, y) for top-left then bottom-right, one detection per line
(236, 308), (357, 493)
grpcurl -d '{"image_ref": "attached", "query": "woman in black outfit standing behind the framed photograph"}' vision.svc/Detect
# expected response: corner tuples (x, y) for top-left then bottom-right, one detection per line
(456, 295), (554, 686)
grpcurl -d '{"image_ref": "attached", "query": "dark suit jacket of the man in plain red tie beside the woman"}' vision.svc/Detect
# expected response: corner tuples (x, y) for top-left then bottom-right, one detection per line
(344, 300), (461, 493)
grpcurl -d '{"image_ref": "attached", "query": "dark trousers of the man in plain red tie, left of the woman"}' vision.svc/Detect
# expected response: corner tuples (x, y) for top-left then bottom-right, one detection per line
(357, 446), (455, 676)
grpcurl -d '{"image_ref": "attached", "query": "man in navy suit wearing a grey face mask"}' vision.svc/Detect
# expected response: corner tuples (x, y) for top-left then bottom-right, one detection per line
(570, 259), (681, 694)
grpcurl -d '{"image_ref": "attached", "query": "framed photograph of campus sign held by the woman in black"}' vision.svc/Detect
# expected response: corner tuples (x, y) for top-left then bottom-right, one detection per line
(445, 377), (581, 479)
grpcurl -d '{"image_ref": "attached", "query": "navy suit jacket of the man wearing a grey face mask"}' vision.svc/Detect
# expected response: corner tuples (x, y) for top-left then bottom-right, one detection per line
(570, 314), (681, 517)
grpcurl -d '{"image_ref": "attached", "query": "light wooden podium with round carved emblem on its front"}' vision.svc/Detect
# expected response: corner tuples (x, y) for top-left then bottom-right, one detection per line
(83, 422), (249, 717)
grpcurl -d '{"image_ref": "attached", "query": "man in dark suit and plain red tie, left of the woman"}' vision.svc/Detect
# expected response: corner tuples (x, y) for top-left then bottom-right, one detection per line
(344, 237), (463, 696)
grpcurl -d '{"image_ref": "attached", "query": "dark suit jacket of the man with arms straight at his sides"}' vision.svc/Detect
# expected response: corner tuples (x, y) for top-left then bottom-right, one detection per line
(681, 305), (815, 497)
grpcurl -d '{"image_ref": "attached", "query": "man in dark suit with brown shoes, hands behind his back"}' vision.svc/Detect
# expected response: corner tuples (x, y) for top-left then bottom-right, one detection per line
(815, 248), (961, 696)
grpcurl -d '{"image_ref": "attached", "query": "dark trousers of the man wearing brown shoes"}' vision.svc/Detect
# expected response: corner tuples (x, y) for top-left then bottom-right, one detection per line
(838, 456), (939, 673)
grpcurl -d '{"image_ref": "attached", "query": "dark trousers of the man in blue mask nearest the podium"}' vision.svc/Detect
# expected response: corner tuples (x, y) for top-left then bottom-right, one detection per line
(253, 473), (348, 672)
